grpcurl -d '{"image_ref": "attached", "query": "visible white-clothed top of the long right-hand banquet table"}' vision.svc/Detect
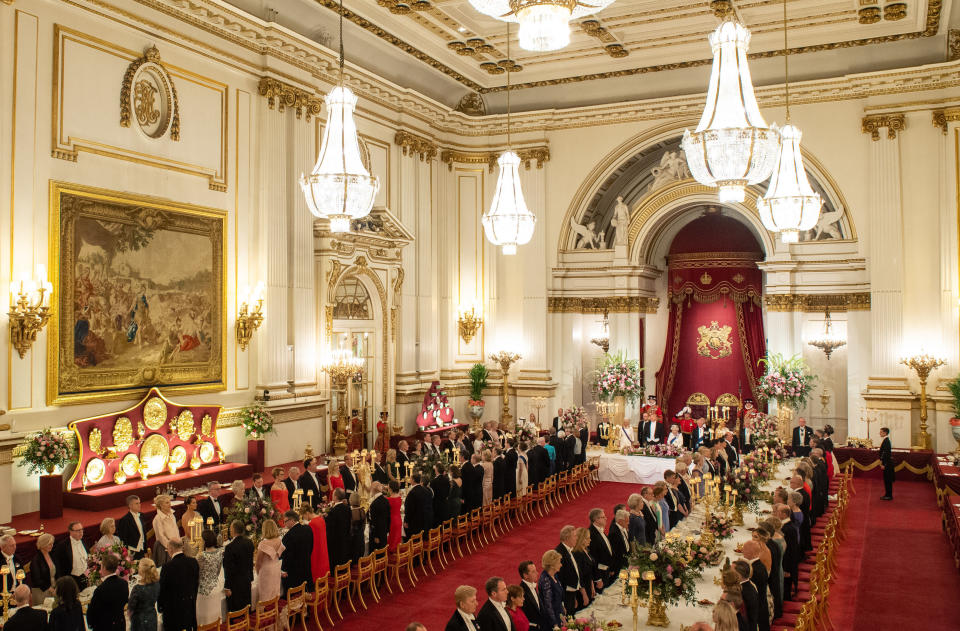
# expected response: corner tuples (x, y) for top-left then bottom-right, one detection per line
(577, 459), (795, 631)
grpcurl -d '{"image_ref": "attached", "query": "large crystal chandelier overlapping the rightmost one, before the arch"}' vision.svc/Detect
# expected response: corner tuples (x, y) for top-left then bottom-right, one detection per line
(683, 18), (780, 202)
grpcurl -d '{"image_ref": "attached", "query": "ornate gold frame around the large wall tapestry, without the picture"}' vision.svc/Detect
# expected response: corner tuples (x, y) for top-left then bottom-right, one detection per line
(47, 180), (228, 405)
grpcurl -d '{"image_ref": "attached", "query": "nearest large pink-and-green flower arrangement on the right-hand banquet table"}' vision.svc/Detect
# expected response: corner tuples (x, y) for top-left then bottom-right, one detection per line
(627, 533), (701, 605)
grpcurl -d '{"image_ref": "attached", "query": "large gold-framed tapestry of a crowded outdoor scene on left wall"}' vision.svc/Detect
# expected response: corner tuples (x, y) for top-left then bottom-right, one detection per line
(48, 183), (225, 404)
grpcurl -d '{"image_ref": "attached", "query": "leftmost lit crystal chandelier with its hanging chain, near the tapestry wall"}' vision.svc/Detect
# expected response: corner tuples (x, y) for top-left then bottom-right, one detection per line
(300, 0), (380, 232)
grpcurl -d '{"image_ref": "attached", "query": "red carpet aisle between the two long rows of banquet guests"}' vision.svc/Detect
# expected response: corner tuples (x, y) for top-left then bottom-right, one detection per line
(330, 482), (641, 631)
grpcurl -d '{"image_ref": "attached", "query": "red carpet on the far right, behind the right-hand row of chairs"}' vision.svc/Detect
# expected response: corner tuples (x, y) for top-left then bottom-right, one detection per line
(830, 477), (960, 631)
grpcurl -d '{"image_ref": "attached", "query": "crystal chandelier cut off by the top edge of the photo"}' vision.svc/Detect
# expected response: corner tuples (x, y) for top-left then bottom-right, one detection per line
(470, 0), (614, 51)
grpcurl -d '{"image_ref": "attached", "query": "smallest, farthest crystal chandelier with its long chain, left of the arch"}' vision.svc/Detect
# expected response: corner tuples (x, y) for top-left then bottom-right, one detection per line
(480, 24), (537, 254)
